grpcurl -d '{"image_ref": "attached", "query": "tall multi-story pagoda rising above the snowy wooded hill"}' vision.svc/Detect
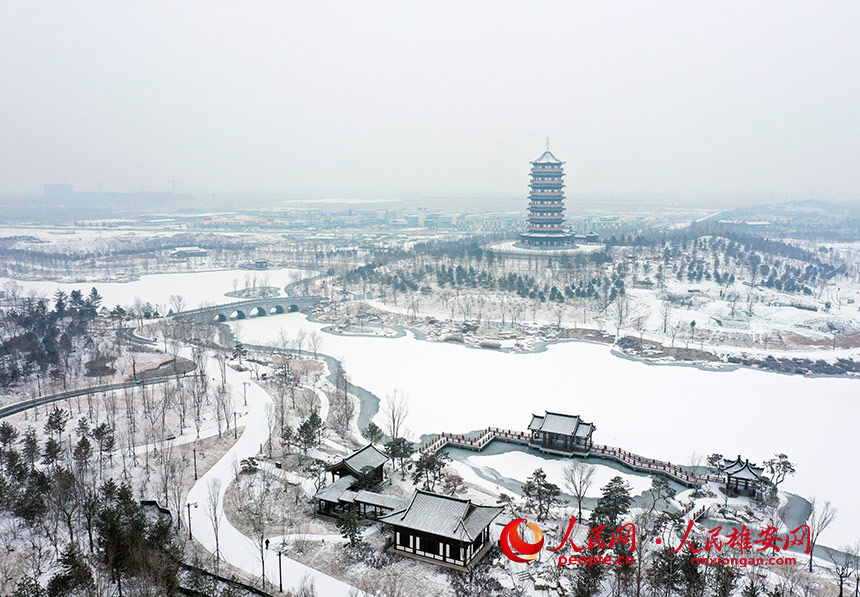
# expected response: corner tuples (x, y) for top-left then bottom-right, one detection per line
(520, 139), (574, 248)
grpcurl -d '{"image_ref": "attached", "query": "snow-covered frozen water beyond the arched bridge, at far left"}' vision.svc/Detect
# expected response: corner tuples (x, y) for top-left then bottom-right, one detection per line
(0, 268), (308, 309)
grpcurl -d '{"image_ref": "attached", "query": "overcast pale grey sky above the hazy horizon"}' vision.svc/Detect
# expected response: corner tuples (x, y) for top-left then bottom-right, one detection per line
(0, 0), (860, 200)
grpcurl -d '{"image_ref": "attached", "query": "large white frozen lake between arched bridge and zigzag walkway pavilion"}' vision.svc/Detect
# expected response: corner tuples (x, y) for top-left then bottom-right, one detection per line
(233, 314), (860, 546)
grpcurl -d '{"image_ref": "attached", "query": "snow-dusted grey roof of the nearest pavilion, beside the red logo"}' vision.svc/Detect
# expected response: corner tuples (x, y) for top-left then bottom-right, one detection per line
(379, 489), (502, 542)
